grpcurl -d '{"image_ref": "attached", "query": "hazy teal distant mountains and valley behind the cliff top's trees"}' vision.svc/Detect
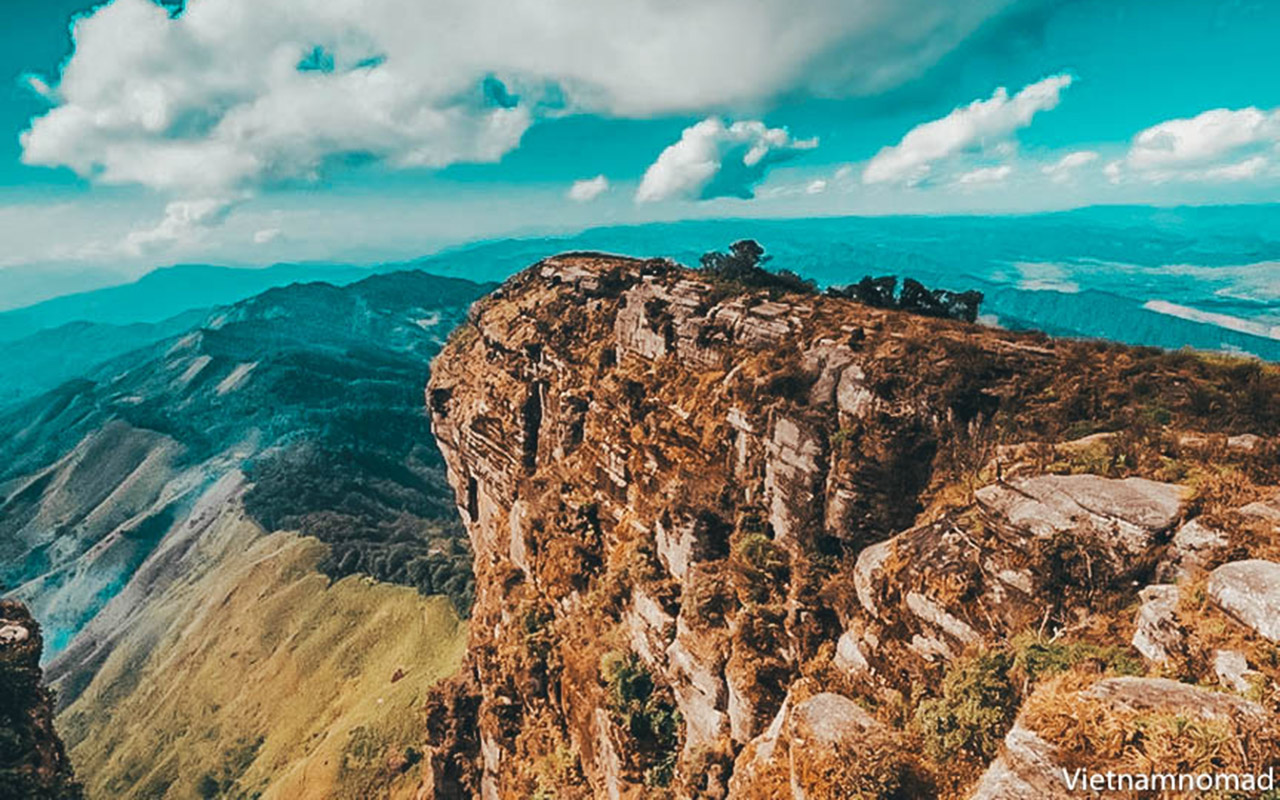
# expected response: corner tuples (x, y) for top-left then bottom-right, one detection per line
(413, 206), (1280, 360)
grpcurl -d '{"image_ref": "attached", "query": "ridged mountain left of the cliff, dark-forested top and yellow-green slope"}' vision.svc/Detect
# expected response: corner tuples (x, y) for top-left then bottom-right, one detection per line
(0, 271), (490, 797)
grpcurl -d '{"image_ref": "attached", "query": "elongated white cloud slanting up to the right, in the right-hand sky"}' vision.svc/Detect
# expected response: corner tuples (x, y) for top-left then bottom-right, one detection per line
(863, 74), (1073, 184)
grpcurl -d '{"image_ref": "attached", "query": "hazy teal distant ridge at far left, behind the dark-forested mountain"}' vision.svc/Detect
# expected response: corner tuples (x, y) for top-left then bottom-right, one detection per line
(0, 258), (372, 342)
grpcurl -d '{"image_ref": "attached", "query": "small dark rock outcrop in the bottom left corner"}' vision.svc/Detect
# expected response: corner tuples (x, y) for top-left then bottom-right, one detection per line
(0, 600), (81, 800)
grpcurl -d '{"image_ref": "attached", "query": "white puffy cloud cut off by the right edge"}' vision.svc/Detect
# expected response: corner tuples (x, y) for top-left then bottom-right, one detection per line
(1108, 106), (1280, 183)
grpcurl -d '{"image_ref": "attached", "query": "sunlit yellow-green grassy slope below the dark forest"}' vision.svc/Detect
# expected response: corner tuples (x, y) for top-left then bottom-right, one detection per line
(59, 515), (466, 800)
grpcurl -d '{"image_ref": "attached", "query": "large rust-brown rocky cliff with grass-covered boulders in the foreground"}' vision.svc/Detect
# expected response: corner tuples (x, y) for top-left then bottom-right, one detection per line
(426, 255), (1280, 797)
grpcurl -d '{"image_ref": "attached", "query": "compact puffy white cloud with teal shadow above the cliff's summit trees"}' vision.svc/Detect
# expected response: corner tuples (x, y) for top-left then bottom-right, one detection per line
(636, 116), (818, 202)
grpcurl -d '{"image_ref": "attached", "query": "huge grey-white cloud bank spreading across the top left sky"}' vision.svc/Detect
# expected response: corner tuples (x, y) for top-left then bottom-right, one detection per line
(23, 0), (1052, 247)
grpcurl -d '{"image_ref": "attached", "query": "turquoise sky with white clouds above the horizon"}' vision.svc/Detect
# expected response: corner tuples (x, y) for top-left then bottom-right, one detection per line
(0, 0), (1280, 287)
